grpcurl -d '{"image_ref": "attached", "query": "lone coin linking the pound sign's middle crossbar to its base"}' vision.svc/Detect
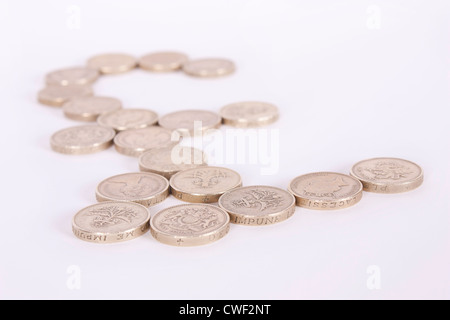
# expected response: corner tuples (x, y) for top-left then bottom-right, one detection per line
(139, 145), (206, 179)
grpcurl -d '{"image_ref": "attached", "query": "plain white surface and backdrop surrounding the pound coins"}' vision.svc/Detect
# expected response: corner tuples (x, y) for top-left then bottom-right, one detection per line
(0, 0), (450, 299)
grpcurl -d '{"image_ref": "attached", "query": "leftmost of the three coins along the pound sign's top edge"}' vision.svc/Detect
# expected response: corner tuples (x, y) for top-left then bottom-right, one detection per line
(87, 53), (137, 74)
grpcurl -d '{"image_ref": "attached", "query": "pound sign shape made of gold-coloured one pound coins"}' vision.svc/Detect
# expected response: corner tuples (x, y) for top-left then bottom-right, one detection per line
(38, 52), (423, 246)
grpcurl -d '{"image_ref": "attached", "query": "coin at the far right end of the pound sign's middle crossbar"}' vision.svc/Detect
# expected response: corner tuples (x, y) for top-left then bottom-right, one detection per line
(220, 101), (279, 128)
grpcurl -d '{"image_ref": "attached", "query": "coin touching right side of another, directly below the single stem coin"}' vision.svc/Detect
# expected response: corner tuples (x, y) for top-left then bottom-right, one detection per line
(170, 167), (242, 203)
